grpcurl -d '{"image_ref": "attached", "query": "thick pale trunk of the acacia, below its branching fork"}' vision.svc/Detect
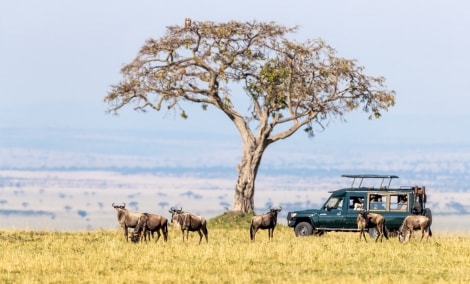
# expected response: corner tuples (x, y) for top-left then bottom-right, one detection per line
(233, 139), (267, 213)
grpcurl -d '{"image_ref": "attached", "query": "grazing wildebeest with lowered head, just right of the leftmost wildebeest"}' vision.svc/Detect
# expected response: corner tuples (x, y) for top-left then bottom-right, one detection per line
(131, 213), (168, 242)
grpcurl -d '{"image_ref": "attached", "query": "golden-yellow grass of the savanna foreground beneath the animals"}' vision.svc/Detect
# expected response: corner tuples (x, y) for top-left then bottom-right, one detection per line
(0, 213), (470, 283)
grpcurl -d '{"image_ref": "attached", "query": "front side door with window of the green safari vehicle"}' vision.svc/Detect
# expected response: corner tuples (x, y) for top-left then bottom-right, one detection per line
(318, 196), (345, 229)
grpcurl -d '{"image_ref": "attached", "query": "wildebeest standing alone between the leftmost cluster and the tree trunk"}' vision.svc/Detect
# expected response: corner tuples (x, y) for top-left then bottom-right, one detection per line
(169, 208), (209, 244)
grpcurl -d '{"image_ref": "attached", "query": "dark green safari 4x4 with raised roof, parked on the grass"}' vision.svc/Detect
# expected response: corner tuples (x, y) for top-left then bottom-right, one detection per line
(287, 175), (432, 236)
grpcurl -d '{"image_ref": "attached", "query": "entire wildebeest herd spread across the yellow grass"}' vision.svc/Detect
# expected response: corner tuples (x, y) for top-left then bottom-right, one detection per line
(112, 203), (432, 244)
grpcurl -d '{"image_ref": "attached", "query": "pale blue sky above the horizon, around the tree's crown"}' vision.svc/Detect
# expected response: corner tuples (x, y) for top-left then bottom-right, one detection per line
(0, 0), (470, 156)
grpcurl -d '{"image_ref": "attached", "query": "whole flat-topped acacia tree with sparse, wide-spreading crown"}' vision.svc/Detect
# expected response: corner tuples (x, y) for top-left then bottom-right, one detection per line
(104, 19), (395, 213)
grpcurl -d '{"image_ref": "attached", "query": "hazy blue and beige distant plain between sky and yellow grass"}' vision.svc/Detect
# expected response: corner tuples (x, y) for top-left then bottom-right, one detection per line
(0, 129), (470, 230)
